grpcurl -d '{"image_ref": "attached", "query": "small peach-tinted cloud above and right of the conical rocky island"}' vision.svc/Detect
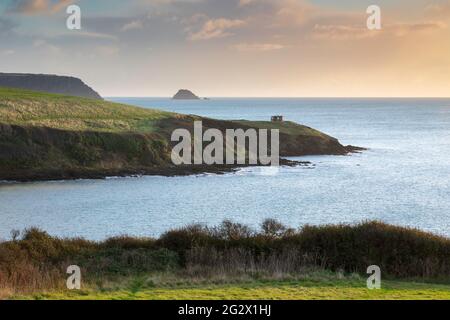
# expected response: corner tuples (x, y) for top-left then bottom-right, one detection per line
(189, 18), (245, 41)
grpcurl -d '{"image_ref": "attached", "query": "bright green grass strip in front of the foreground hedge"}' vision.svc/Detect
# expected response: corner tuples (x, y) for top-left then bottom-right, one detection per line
(11, 274), (450, 300)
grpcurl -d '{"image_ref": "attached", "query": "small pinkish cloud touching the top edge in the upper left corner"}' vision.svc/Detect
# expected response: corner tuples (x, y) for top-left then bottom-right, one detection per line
(9, 0), (77, 15)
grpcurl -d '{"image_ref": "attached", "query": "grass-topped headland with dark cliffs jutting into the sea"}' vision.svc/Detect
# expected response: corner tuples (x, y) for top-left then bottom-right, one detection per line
(0, 88), (355, 181)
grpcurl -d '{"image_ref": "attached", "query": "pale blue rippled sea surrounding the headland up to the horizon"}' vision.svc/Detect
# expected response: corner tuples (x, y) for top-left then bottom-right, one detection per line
(0, 97), (450, 240)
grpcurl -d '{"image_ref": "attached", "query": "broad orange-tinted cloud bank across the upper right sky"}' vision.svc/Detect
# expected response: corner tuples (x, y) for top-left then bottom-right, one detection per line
(234, 0), (444, 43)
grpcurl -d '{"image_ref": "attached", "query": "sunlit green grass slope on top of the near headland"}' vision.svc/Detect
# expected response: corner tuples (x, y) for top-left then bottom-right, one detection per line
(0, 88), (176, 132)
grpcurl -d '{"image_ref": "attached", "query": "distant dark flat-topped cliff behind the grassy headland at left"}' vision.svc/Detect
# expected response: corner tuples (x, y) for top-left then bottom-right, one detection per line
(0, 73), (102, 99)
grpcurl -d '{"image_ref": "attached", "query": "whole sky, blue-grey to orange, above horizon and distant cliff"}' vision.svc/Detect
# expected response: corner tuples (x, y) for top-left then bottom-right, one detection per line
(0, 0), (450, 97)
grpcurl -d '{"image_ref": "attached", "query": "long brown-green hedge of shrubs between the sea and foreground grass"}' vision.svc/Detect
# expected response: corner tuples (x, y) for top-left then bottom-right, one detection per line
(0, 220), (450, 290)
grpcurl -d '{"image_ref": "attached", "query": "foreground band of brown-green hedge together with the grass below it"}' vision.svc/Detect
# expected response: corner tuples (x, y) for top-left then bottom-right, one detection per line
(0, 220), (450, 299)
